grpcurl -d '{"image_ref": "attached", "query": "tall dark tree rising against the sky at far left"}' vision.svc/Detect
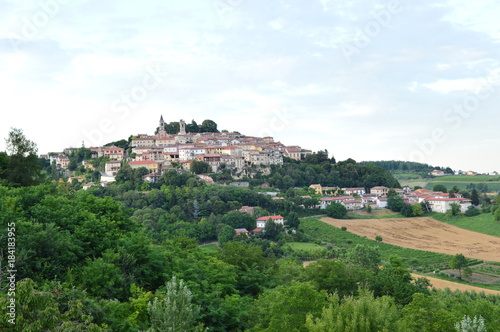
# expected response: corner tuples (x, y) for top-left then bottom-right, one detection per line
(5, 128), (41, 186)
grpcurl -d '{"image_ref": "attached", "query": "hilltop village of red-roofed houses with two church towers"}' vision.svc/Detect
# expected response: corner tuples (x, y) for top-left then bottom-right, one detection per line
(90, 116), (312, 180)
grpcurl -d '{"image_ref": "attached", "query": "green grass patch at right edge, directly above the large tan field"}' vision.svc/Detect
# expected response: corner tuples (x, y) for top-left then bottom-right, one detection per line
(425, 212), (500, 237)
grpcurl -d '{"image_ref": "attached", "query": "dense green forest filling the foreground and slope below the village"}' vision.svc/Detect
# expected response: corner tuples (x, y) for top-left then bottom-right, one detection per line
(0, 133), (500, 332)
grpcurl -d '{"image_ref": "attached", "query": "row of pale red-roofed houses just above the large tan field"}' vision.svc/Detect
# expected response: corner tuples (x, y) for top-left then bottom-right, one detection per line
(310, 185), (472, 213)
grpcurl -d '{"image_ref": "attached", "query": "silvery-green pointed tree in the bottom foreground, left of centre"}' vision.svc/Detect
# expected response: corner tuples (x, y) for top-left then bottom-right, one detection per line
(148, 275), (202, 332)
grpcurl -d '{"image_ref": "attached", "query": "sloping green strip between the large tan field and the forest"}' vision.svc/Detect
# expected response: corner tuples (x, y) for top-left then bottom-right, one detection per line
(300, 218), (458, 272)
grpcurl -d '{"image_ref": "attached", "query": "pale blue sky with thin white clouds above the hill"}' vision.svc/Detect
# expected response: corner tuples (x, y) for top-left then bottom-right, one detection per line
(0, 0), (500, 172)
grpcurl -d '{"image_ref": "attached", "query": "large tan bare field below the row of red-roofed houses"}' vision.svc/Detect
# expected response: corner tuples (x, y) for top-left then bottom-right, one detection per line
(321, 217), (500, 262)
